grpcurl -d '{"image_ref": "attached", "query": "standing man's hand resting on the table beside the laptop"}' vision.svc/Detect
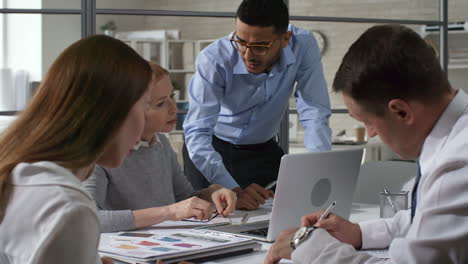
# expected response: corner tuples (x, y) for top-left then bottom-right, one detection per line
(233, 183), (274, 210)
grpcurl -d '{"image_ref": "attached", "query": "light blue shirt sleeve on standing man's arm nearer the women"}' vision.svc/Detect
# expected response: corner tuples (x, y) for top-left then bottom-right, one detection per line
(184, 52), (239, 189)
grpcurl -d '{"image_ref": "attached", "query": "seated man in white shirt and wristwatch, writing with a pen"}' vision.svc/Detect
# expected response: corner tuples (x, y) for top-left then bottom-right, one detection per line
(265, 25), (468, 263)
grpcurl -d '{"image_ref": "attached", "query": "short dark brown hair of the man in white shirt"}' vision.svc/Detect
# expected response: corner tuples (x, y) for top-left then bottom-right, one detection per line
(333, 25), (450, 116)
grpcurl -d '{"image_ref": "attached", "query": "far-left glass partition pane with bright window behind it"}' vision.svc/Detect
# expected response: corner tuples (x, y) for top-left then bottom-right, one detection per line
(0, 14), (81, 111)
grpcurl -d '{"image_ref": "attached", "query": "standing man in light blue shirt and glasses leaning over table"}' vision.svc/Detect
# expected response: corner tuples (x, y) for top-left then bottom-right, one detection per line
(184, 0), (331, 210)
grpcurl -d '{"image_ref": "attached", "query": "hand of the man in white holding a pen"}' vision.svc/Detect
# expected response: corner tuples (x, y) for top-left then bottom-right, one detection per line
(301, 210), (362, 249)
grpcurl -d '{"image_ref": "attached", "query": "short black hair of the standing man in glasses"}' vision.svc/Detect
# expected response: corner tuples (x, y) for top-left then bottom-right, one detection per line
(237, 0), (289, 33)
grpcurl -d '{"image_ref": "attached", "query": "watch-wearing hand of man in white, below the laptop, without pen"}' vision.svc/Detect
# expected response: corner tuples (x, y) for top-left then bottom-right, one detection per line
(264, 228), (298, 264)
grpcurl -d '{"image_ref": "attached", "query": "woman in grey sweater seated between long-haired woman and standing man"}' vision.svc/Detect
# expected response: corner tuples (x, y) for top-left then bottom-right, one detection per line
(84, 64), (236, 232)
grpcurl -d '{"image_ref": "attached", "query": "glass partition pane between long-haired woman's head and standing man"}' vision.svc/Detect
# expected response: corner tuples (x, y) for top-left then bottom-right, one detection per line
(96, 15), (234, 102)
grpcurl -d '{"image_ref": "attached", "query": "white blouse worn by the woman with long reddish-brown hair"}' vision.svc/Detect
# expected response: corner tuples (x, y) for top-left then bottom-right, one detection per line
(0, 161), (101, 264)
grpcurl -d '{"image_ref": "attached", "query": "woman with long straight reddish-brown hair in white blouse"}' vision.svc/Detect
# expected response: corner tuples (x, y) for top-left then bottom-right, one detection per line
(0, 36), (151, 264)
